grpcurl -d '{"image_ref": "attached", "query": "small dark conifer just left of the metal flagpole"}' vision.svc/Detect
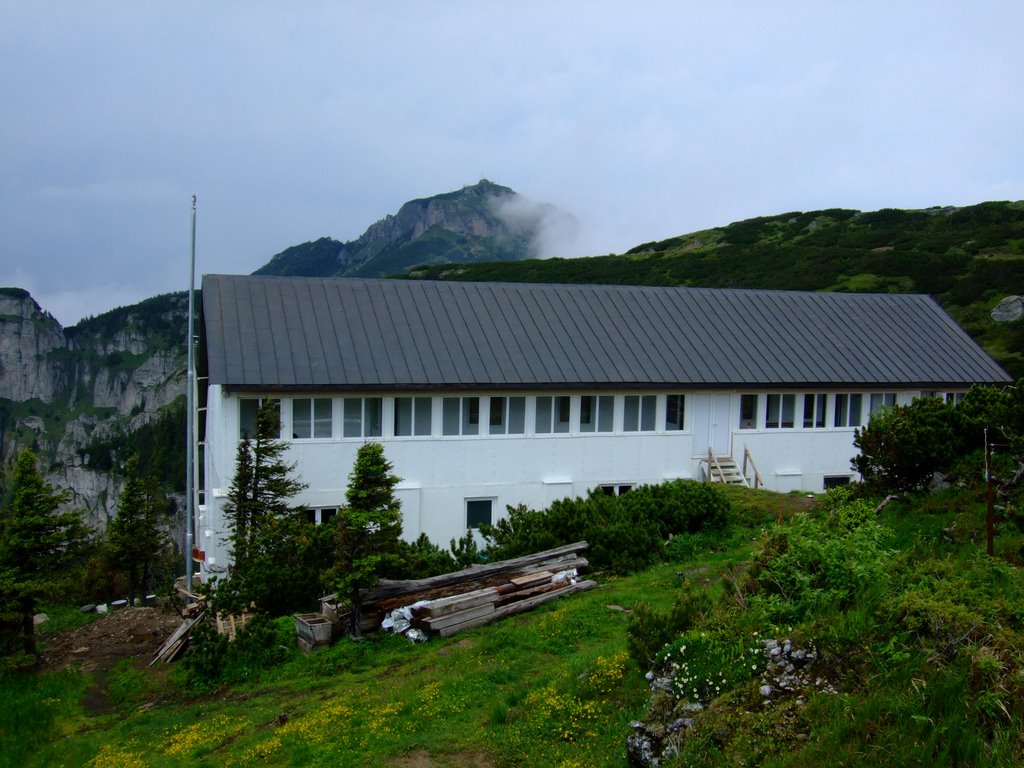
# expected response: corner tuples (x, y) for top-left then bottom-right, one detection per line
(108, 454), (168, 605)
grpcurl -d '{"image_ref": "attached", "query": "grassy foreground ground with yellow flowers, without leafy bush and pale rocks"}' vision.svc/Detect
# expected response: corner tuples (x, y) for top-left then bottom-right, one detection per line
(0, 489), (1024, 768)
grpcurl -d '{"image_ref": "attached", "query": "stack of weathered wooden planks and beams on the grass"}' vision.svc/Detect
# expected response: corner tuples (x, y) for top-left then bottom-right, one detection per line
(365, 542), (597, 637)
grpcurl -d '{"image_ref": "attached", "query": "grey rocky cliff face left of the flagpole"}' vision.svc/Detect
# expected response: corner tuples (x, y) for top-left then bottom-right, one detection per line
(0, 289), (186, 527)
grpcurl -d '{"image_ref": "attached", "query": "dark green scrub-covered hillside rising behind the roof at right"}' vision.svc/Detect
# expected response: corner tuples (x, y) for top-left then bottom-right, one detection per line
(411, 202), (1024, 378)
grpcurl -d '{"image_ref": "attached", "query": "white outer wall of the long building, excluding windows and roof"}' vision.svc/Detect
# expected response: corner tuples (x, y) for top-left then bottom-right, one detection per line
(196, 386), (937, 572)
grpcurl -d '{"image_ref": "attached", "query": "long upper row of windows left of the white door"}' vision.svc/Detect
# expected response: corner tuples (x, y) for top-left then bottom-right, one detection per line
(239, 394), (686, 440)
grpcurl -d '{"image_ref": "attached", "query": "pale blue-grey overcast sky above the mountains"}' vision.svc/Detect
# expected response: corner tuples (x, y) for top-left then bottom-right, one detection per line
(0, 0), (1024, 325)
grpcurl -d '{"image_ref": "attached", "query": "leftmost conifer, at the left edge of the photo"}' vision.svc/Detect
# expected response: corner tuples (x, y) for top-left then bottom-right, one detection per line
(0, 449), (87, 662)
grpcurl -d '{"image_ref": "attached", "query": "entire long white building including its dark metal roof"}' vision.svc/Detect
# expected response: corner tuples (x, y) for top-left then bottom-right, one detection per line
(195, 275), (1010, 571)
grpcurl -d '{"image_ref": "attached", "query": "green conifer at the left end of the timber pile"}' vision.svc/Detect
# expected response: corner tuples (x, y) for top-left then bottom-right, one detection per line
(332, 442), (401, 639)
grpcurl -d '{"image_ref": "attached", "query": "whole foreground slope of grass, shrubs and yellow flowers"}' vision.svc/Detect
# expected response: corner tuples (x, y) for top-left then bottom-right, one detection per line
(0, 486), (1024, 768)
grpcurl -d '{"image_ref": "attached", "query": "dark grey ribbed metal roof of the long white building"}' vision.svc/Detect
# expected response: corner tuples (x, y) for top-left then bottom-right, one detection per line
(197, 274), (1011, 390)
